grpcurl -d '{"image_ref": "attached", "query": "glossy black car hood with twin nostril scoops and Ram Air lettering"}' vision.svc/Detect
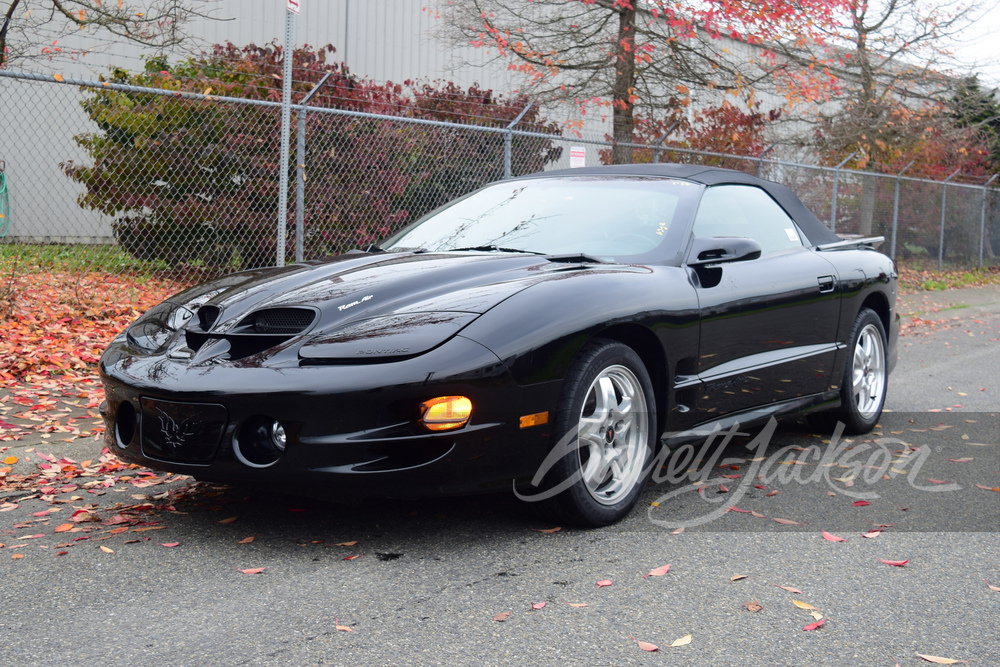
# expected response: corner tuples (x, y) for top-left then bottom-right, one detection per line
(156, 252), (622, 362)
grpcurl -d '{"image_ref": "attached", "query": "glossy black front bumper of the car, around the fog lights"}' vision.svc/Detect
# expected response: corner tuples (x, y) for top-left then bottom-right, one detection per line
(101, 336), (559, 498)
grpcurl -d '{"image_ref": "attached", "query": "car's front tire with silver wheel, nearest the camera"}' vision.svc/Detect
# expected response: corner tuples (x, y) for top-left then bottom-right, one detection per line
(540, 339), (657, 526)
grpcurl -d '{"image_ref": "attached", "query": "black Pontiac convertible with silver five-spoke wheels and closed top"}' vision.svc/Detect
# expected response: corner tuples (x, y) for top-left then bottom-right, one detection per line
(101, 165), (899, 525)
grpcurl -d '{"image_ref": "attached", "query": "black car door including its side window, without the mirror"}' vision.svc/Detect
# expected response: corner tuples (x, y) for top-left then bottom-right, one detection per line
(691, 185), (840, 421)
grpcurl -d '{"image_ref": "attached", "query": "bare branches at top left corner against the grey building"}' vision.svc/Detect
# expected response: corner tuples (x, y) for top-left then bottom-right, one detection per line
(0, 0), (223, 67)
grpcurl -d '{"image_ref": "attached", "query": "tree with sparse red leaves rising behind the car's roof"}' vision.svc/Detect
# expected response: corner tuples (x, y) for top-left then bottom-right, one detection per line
(440, 0), (837, 163)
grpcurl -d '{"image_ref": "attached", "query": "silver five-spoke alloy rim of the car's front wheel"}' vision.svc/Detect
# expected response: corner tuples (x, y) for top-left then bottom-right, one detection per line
(578, 365), (649, 505)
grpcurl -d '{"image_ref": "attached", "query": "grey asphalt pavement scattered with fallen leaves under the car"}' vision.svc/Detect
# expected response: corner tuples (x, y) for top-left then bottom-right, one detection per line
(0, 287), (1000, 667)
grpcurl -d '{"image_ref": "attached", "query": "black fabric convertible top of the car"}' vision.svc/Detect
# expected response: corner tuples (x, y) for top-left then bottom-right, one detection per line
(522, 164), (841, 245)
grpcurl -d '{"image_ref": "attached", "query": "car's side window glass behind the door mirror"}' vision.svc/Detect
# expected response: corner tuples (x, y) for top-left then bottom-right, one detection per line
(694, 185), (802, 255)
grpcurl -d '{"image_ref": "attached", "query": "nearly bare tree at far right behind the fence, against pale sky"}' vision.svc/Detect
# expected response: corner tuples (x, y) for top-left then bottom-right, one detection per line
(776, 0), (997, 235)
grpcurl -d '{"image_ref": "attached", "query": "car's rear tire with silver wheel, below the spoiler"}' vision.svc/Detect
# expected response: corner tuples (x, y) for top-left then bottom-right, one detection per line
(837, 308), (888, 435)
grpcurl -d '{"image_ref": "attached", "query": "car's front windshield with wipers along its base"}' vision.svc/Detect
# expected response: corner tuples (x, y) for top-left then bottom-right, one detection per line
(382, 176), (699, 258)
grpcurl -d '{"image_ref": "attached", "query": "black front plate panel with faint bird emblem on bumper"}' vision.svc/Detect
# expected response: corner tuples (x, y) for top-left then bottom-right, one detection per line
(139, 398), (229, 463)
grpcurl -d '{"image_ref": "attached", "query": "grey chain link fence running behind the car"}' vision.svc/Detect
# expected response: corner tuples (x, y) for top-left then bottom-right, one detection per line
(0, 70), (1000, 280)
